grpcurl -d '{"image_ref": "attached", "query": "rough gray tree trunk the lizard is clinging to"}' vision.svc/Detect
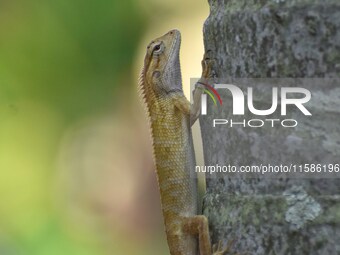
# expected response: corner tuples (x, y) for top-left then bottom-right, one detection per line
(200, 0), (340, 255)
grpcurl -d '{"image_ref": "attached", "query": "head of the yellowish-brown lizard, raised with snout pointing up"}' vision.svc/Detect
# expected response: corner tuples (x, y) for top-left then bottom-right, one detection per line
(141, 29), (182, 96)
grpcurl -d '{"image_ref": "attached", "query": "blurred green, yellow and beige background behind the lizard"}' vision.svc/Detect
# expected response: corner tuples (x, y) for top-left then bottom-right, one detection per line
(0, 0), (209, 255)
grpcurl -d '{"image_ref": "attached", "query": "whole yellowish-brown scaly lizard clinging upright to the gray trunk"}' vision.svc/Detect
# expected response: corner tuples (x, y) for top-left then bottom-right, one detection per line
(140, 29), (228, 255)
